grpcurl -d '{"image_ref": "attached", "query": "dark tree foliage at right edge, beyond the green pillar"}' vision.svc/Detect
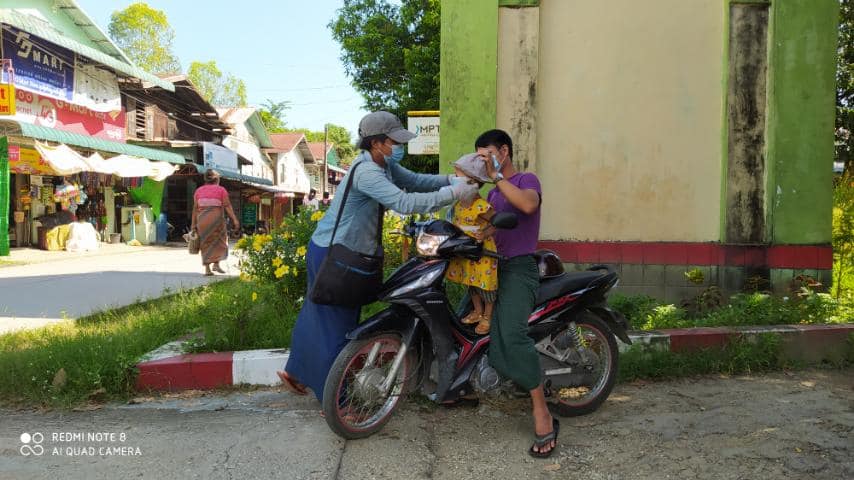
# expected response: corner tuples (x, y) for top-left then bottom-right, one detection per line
(836, 0), (854, 171)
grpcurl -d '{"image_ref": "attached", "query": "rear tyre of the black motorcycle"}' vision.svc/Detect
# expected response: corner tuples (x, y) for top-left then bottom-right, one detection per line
(549, 312), (620, 417)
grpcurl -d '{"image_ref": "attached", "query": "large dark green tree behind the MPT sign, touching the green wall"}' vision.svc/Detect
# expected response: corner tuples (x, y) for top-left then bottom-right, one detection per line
(329, 0), (440, 118)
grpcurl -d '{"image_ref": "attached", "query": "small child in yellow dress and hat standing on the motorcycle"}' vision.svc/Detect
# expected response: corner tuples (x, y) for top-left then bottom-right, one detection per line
(446, 153), (498, 335)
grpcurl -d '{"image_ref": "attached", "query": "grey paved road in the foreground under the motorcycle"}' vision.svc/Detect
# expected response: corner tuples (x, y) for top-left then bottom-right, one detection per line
(0, 369), (854, 480)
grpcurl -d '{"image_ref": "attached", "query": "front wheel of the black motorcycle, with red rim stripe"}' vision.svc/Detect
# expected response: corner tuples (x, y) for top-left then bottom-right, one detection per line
(323, 333), (413, 440)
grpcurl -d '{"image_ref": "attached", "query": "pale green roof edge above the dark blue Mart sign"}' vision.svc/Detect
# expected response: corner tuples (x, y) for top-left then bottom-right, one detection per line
(0, 9), (175, 92)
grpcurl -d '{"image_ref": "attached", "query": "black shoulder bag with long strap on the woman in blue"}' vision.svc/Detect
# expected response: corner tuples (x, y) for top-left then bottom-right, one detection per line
(309, 162), (384, 307)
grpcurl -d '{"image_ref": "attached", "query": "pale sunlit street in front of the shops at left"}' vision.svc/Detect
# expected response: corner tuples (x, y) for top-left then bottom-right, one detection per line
(0, 247), (238, 333)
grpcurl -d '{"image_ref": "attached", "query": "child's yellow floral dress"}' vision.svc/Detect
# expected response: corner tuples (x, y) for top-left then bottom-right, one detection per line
(445, 198), (498, 291)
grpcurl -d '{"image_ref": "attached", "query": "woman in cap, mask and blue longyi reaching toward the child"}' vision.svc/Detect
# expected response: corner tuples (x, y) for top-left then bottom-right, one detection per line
(277, 112), (477, 401)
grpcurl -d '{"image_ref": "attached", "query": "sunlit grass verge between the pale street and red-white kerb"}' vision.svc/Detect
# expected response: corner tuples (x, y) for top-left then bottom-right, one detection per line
(0, 280), (251, 407)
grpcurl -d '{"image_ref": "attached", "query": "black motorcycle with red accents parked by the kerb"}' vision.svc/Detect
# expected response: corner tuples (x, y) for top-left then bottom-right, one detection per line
(323, 213), (631, 439)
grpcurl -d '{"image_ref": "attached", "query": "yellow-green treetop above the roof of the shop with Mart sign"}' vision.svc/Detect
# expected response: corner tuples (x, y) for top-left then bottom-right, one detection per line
(108, 2), (181, 73)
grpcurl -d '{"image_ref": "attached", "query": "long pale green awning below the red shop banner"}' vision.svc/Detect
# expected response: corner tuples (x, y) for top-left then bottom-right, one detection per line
(0, 120), (184, 165)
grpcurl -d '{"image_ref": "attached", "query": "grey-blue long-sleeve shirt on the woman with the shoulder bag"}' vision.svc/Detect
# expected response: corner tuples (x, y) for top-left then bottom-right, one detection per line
(311, 151), (454, 254)
